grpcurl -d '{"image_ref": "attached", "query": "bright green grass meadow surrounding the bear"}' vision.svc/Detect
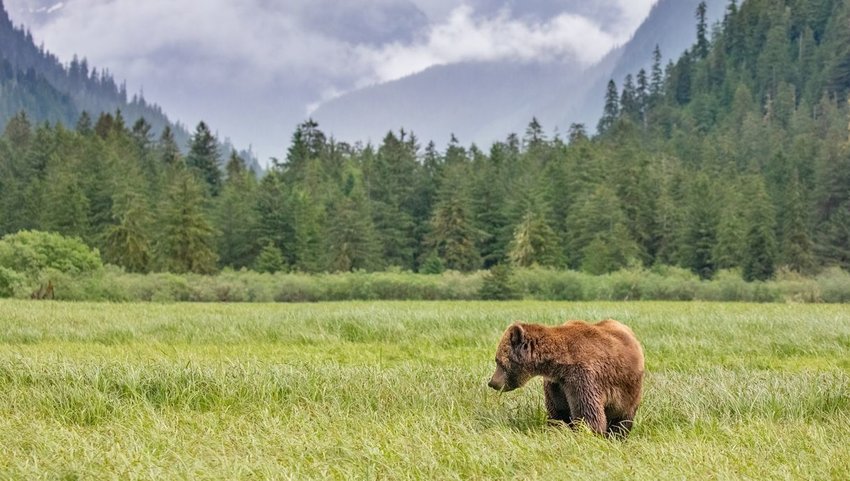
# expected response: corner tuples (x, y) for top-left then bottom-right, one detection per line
(0, 301), (850, 480)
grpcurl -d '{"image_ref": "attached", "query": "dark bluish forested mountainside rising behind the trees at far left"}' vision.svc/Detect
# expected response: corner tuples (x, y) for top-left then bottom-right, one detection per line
(0, 0), (261, 172)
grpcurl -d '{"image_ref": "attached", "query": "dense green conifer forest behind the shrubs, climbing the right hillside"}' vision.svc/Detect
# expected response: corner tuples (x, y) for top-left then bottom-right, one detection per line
(0, 0), (850, 280)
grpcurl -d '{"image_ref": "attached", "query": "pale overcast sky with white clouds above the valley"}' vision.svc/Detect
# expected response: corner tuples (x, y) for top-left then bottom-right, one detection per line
(5, 0), (654, 159)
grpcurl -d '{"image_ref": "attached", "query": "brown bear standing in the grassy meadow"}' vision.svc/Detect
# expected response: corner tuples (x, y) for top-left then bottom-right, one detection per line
(489, 320), (643, 437)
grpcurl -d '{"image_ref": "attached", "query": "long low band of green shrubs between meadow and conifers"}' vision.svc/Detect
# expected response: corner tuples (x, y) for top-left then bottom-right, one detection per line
(6, 258), (850, 303)
